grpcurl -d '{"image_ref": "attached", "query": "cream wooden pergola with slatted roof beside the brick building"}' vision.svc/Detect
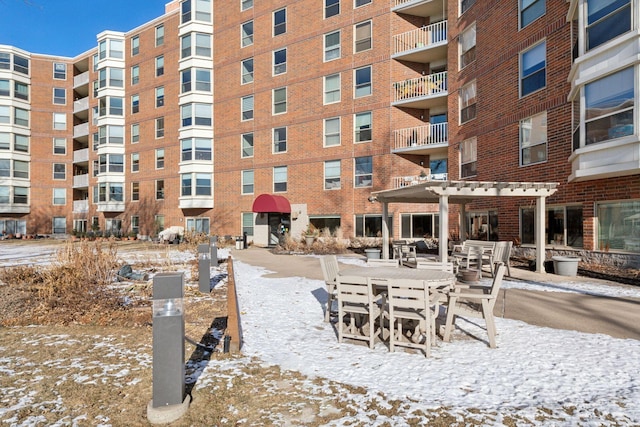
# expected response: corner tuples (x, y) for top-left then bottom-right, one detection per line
(369, 181), (558, 273)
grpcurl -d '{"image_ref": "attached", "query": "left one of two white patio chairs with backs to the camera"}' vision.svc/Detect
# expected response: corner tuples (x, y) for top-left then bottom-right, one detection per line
(336, 276), (380, 348)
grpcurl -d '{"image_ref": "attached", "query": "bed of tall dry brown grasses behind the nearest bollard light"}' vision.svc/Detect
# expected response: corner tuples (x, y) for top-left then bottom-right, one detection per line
(0, 240), (150, 326)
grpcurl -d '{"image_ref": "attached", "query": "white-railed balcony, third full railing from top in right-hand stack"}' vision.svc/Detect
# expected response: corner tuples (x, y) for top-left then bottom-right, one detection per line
(392, 123), (449, 155)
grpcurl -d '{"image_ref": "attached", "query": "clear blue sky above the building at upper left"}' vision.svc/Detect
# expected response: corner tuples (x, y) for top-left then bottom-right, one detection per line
(0, 0), (170, 57)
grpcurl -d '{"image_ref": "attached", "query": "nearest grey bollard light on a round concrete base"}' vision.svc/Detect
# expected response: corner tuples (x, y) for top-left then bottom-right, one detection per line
(147, 273), (191, 424)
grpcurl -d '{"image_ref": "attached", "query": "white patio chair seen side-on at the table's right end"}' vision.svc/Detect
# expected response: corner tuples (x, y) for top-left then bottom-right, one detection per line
(442, 262), (506, 348)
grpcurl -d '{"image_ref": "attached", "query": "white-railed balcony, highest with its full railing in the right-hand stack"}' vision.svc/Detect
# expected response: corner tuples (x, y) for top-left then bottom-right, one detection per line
(391, 21), (447, 64)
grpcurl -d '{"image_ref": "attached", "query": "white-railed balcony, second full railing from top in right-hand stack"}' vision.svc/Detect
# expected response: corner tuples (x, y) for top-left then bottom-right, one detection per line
(393, 71), (449, 109)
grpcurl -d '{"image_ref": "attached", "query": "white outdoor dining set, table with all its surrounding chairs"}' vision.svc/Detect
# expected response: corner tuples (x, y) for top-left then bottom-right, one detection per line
(320, 242), (510, 357)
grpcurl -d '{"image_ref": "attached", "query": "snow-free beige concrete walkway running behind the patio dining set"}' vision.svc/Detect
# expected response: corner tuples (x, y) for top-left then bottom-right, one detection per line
(231, 247), (640, 340)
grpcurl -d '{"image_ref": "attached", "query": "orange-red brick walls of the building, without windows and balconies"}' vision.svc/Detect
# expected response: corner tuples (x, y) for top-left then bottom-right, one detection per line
(0, 0), (640, 258)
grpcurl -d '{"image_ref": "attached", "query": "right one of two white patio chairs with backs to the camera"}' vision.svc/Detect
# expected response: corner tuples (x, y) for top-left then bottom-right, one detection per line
(387, 279), (435, 357)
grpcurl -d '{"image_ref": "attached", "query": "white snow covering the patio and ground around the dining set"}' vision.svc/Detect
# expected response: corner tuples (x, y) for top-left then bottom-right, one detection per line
(0, 242), (640, 426)
